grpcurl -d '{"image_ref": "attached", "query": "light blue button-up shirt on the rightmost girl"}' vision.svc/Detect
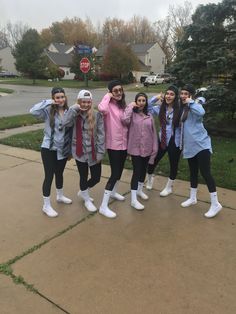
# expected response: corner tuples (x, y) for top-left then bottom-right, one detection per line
(183, 100), (212, 158)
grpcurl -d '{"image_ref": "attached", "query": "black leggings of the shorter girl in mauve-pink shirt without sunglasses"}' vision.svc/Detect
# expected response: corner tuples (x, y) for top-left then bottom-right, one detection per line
(131, 156), (150, 190)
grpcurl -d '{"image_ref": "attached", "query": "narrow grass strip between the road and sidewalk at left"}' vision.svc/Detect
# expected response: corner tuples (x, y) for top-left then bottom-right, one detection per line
(0, 113), (43, 130)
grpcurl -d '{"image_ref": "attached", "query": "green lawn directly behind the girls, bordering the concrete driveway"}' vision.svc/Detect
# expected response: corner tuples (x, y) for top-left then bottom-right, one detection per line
(0, 130), (236, 190)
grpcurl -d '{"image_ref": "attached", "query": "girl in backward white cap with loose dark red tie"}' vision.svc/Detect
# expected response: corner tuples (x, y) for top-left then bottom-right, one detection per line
(63, 90), (105, 212)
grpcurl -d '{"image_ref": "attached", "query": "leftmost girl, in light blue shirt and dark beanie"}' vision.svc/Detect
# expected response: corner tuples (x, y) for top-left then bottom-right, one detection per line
(30, 87), (72, 217)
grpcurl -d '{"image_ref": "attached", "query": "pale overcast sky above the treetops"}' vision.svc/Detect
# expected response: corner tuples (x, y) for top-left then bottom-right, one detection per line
(0, 0), (221, 31)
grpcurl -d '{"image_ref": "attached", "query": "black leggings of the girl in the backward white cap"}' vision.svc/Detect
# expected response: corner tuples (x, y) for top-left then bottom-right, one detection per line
(76, 160), (102, 191)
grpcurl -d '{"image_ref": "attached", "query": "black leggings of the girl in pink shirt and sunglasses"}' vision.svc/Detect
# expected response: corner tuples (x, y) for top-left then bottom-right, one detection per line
(105, 149), (127, 191)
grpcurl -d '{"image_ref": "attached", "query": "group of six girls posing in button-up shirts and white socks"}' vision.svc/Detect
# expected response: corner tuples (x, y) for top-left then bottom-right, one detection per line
(30, 80), (222, 218)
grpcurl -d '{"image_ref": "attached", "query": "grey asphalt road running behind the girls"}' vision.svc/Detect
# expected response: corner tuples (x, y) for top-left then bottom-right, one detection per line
(0, 84), (155, 117)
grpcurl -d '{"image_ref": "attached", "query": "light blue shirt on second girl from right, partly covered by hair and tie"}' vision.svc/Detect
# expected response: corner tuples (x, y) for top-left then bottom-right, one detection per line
(148, 96), (180, 147)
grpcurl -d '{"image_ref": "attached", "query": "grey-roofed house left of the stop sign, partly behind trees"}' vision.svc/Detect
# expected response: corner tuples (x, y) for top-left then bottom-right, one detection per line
(44, 43), (75, 80)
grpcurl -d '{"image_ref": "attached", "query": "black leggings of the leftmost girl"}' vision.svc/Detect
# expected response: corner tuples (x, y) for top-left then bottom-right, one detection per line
(41, 148), (67, 197)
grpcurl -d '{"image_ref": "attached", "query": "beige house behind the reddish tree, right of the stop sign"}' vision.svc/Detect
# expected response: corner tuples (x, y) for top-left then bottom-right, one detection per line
(96, 43), (166, 82)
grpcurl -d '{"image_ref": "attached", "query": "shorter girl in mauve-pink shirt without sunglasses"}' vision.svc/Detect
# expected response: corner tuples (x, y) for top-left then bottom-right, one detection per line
(123, 93), (158, 210)
